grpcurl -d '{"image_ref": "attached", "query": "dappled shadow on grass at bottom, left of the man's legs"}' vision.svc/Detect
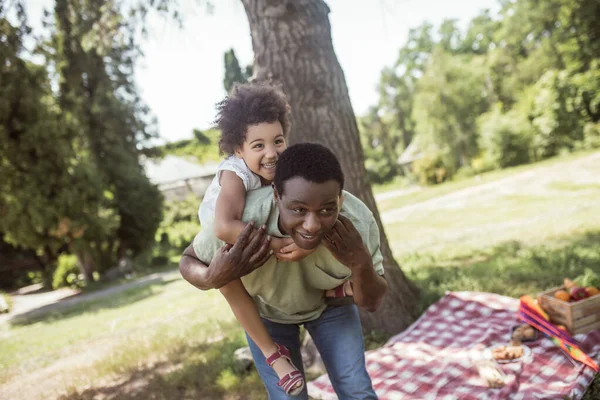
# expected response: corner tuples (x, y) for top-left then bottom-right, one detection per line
(59, 330), (265, 400)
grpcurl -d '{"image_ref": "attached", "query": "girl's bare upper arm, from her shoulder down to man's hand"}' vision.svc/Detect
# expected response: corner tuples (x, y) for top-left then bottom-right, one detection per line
(215, 171), (246, 243)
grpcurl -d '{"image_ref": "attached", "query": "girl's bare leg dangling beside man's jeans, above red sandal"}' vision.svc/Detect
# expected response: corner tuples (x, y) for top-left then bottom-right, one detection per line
(220, 279), (302, 390)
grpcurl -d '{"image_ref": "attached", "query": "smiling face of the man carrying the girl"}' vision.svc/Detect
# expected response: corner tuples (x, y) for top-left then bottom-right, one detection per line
(275, 177), (343, 250)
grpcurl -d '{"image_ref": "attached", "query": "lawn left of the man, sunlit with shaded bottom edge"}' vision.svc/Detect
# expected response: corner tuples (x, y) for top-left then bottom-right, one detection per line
(0, 272), (264, 399)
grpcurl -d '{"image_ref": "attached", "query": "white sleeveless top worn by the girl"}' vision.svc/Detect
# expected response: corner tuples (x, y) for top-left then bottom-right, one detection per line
(198, 155), (262, 226)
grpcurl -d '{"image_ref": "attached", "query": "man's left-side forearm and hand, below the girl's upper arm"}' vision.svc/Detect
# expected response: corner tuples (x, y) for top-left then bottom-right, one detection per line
(179, 222), (273, 290)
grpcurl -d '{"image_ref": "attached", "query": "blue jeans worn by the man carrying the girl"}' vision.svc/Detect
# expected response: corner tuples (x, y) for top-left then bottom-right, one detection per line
(246, 304), (377, 400)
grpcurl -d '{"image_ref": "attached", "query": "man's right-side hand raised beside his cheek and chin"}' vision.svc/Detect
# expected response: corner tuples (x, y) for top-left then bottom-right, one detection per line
(323, 214), (372, 270)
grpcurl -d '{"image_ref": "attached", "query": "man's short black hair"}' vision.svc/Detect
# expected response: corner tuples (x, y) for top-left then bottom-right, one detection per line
(273, 143), (344, 195)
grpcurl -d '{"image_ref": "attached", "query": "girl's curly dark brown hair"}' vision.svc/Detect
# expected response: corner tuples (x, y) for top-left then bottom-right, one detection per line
(215, 83), (291, 155)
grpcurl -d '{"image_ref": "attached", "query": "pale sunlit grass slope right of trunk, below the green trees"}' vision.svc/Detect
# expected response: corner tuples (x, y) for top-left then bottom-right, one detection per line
(382, 150), (600, 257)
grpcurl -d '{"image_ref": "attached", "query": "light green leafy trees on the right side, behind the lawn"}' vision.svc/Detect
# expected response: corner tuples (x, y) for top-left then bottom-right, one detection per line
(362, 0), (600, 184)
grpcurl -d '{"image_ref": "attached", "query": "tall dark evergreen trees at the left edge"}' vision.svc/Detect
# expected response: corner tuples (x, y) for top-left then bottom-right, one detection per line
(0, 0), (162, 283)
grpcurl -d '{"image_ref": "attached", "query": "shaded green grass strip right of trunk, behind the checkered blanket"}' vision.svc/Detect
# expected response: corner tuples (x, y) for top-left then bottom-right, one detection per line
(400, 232), (600, 314)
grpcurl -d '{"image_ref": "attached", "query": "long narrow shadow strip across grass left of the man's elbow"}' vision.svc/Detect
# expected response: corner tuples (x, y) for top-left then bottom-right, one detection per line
(10, 278), (180, 326)
